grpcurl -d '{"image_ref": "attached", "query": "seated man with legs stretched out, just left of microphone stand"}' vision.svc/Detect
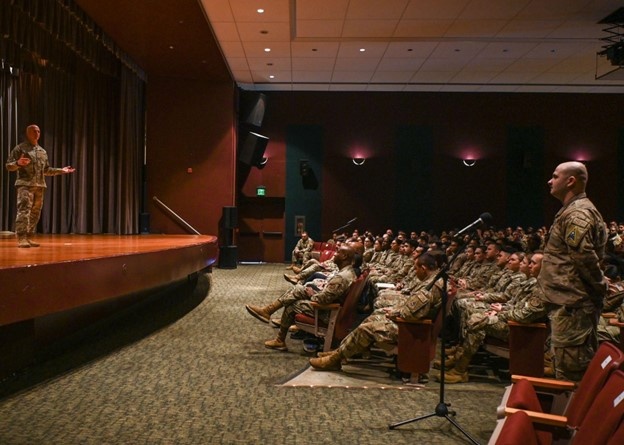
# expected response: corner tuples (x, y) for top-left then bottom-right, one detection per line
(310, 253), (442, 371)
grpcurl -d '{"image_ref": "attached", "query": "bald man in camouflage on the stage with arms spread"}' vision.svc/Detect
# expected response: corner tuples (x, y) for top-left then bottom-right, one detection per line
(6, 125), (75, 247)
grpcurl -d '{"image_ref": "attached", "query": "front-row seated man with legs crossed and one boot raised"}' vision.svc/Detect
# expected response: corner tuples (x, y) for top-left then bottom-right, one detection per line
(245, 244), (356, 351)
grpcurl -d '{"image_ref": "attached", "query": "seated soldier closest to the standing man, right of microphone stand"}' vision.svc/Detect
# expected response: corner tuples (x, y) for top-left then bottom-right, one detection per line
(438, 253), (547, 383)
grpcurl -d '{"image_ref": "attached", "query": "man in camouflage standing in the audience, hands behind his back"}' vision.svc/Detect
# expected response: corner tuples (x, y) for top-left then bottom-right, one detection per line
(537, 162), (607, 382)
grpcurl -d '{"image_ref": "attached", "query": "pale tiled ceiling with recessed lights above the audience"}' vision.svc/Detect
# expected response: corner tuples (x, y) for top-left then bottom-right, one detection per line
(198, 0), (624, 93)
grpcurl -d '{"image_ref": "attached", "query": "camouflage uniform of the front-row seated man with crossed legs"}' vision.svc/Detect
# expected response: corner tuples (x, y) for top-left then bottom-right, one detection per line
(277, 265), (356, 332)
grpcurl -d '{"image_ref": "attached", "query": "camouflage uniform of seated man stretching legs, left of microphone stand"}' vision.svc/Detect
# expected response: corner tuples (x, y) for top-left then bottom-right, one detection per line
(337, 274), (443, 358)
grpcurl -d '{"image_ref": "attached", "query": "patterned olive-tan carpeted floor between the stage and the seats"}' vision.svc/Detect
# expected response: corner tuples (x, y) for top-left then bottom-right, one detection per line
(0, 264), (504, 445)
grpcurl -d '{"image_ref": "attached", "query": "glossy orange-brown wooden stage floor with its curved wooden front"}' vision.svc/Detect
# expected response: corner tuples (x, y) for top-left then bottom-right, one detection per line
(0, 235), (218, 326)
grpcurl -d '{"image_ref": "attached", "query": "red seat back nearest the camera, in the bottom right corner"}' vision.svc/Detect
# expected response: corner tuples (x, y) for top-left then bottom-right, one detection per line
(572, 370), (624, 445)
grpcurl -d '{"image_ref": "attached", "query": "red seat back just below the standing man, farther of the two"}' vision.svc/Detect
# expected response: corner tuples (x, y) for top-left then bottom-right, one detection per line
(565, 342), (624, 428)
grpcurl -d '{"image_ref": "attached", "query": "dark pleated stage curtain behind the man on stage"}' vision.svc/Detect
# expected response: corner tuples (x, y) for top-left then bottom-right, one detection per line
(0, 0), (146, 234)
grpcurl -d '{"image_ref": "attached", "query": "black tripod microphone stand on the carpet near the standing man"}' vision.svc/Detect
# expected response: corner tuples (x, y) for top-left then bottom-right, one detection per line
(388, 233), (479, 445)
